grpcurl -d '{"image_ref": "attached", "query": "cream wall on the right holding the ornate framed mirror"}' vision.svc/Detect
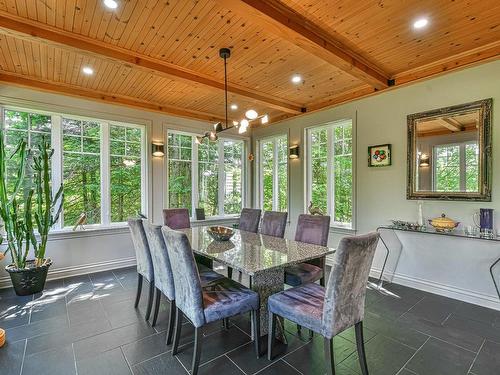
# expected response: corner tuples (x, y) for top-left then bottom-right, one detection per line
(252, 61), (500, 309)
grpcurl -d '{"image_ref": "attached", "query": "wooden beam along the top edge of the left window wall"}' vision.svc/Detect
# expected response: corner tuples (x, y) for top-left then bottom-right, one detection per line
(0, 72), (224, 122)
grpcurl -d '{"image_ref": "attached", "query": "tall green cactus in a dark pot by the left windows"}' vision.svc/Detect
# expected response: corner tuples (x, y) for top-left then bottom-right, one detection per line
(0, 131), (64, 295)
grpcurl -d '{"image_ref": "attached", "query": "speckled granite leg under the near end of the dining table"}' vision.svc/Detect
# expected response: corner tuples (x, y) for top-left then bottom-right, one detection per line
(251, 268), (285, 336)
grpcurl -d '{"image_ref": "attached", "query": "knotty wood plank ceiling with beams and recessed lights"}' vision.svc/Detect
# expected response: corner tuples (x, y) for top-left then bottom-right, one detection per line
(0, 0), (500, 122)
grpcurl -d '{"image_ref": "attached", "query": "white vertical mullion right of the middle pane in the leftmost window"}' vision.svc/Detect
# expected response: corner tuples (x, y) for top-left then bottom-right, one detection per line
(101, 122), (111, 225)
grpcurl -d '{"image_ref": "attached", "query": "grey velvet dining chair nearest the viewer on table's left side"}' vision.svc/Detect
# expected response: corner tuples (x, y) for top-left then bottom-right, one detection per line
(162, 227), (260, 375)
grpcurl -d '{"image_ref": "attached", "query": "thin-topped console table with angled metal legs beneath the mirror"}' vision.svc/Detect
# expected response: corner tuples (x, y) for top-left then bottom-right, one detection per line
(376, 225), (500, 299)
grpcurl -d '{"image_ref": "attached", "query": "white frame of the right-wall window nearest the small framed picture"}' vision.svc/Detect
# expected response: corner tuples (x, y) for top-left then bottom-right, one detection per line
(304, 118), (357, 232)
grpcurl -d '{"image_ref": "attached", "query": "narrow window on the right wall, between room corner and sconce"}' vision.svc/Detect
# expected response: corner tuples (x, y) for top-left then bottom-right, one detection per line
(259, 135), (288, 211)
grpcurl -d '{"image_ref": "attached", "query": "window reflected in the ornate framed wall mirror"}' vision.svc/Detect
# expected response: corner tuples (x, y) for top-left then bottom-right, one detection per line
(433, 142), (479, 192)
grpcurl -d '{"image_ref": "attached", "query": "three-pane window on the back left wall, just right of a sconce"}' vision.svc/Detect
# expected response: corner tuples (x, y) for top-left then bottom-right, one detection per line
(167, 131), (244, 216)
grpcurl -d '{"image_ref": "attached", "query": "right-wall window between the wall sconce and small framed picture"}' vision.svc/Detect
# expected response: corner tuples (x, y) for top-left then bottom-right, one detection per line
(306, 120), (353, 228)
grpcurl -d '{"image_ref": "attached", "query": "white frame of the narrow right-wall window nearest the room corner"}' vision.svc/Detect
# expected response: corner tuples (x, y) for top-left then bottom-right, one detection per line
(256, 133), (290, 212)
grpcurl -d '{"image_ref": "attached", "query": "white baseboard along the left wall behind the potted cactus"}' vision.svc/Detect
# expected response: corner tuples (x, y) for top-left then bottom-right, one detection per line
(0, 257), (136, 289)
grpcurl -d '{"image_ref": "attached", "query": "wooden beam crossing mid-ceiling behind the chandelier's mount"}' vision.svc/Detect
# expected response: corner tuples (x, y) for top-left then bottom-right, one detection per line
(0, 11), (304, 114)
